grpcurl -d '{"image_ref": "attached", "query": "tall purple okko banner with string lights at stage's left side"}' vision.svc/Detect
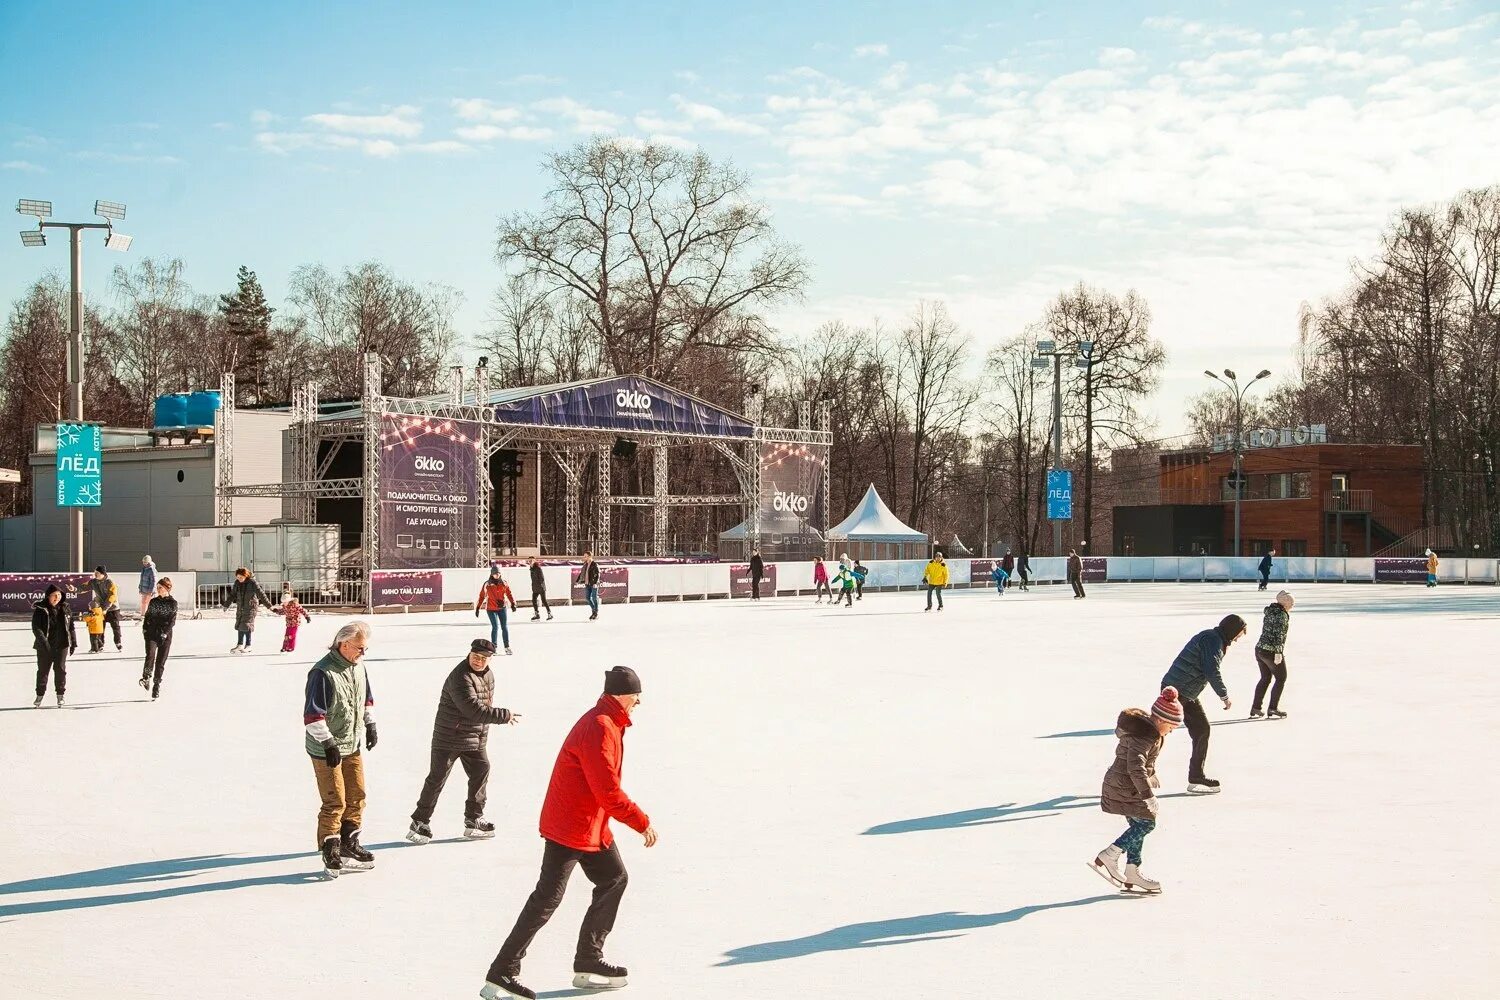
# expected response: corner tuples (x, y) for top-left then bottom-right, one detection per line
(377, 415), (480, 570)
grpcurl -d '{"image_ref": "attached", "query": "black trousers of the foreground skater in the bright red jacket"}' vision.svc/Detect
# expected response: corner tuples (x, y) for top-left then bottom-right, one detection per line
(489, 841), (630, 982)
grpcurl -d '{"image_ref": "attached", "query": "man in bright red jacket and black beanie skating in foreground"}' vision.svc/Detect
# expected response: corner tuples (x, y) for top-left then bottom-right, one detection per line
(479, 667), (657, 1000)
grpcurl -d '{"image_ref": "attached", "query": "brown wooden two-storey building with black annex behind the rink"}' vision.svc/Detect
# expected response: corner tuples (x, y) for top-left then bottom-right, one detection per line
(1115, 444), (1428, 556)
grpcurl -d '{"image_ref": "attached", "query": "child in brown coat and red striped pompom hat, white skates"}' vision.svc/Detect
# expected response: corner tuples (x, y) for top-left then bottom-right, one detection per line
(1092, 687), (1182, 892)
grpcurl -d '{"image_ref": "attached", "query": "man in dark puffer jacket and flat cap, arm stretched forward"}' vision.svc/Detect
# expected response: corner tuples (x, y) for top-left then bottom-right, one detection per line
(407, 639), (521, 844)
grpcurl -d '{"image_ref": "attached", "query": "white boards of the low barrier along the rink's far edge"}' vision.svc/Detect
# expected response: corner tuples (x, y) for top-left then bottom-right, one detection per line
(348, 556), (1500, 615)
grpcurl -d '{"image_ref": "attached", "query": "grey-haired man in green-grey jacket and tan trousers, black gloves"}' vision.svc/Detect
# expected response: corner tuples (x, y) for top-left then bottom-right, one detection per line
(302, 622), (378, 879)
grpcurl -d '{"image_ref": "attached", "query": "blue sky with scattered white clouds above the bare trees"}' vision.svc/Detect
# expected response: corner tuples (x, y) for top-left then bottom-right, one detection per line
(0, 0), (1500, 433)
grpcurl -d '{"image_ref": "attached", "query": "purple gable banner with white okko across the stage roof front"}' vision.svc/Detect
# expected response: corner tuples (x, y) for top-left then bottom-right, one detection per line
(495, 375), (755, 438)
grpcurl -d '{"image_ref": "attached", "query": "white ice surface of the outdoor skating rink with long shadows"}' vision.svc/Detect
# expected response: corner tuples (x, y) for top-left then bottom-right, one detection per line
(0, 585), (1500, 1000)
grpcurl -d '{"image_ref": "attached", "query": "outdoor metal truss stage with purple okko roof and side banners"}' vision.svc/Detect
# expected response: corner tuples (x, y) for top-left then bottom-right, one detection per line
(216, 354), (833, 611)
